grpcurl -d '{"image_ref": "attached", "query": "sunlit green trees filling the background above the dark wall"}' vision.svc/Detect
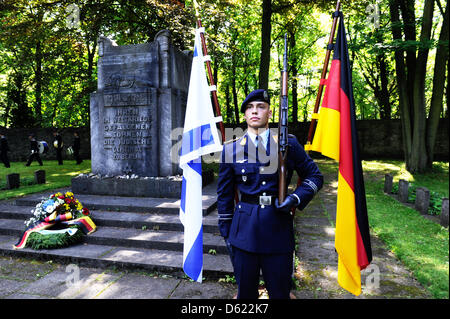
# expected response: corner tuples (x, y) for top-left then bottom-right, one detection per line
(0, 0), (449, 171)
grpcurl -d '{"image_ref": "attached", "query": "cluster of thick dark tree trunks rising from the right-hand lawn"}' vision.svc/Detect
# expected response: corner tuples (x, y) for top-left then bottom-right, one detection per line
(389, 0), (449, 173)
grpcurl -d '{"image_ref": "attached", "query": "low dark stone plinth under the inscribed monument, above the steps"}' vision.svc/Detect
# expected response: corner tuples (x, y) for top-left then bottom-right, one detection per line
(72, 170), (214, 198)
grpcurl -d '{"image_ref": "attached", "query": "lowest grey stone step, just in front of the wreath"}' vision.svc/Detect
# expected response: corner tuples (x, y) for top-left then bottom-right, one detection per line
(0, 235), (233, 278)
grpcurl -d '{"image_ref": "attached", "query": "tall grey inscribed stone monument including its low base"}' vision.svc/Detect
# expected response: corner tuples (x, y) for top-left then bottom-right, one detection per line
(72, 30), (214, 197)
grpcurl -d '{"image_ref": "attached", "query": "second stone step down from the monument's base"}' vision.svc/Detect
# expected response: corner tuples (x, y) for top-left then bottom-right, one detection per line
(0, 204), (219, 233)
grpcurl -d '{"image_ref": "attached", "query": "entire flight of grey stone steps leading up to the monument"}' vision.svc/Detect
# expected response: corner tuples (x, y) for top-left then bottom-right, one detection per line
(0, 186), (229, 278)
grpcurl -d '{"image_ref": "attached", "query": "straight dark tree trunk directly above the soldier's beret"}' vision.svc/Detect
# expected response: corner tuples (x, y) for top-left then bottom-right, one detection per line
(259, 0), (272, 90)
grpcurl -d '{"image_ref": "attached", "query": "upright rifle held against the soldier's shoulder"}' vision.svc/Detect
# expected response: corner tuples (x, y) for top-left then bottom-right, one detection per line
(278, 34), (288, 203)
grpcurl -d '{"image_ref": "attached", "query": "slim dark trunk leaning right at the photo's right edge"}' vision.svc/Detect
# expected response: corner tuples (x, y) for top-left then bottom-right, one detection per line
(427, 1), (449, 168)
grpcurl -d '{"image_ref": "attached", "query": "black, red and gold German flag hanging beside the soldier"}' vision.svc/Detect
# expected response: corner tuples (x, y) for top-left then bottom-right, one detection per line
(311, 13), (372, 295)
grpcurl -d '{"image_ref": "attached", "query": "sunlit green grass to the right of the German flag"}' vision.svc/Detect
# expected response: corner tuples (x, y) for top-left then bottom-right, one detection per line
(317, 160), (449, 298)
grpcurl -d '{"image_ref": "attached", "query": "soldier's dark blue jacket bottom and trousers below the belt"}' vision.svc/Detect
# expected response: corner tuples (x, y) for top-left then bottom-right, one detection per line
(227, 201), (294, 299)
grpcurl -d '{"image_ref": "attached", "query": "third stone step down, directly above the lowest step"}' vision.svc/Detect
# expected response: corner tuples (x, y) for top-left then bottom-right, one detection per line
(0, 219), (228, 254)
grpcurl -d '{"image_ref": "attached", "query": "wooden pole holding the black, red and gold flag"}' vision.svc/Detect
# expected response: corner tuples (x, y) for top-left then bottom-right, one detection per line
(305, 1), (341, 151)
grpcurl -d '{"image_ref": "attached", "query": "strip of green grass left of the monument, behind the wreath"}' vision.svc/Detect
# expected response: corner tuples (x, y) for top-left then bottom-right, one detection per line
(0, 160), (91, 200)
